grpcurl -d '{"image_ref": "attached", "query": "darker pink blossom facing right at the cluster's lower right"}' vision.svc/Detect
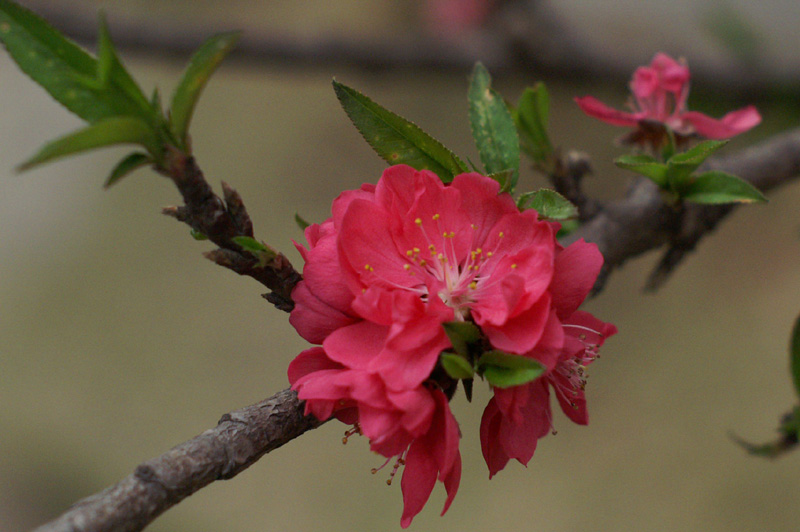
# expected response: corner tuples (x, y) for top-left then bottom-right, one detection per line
(480, 311), (617, 478)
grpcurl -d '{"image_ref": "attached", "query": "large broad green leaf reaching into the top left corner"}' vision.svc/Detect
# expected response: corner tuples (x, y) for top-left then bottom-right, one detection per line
(0, 0), (152, 123)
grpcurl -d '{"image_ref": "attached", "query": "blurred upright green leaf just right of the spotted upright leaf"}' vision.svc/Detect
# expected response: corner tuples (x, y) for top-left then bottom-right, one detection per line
(513, 83), (553, 163)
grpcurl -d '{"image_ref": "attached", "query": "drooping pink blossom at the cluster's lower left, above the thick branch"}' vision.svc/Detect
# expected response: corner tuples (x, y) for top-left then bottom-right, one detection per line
(289, 347), (461, 528)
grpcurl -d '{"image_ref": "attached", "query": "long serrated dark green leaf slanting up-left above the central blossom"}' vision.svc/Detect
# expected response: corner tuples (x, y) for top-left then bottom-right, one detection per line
(333, 80), (469, 183)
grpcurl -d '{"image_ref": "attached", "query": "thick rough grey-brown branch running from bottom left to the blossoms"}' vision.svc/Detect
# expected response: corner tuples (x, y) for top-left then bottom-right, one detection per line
(36, 390), (322, 532)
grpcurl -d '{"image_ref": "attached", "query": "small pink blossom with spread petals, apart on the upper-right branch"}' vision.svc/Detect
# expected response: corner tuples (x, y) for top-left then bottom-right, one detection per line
(575, 53), (761, 147)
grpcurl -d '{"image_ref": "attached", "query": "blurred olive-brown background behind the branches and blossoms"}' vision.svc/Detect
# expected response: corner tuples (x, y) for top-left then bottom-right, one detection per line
(0, 0), (800, 532)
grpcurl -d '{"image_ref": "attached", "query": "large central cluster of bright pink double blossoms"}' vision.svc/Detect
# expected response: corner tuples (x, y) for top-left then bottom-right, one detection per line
(289, 165), (616, 527)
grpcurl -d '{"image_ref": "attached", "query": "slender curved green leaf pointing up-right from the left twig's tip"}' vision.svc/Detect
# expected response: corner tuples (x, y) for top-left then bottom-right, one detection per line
(169, 32), (241, 147)
